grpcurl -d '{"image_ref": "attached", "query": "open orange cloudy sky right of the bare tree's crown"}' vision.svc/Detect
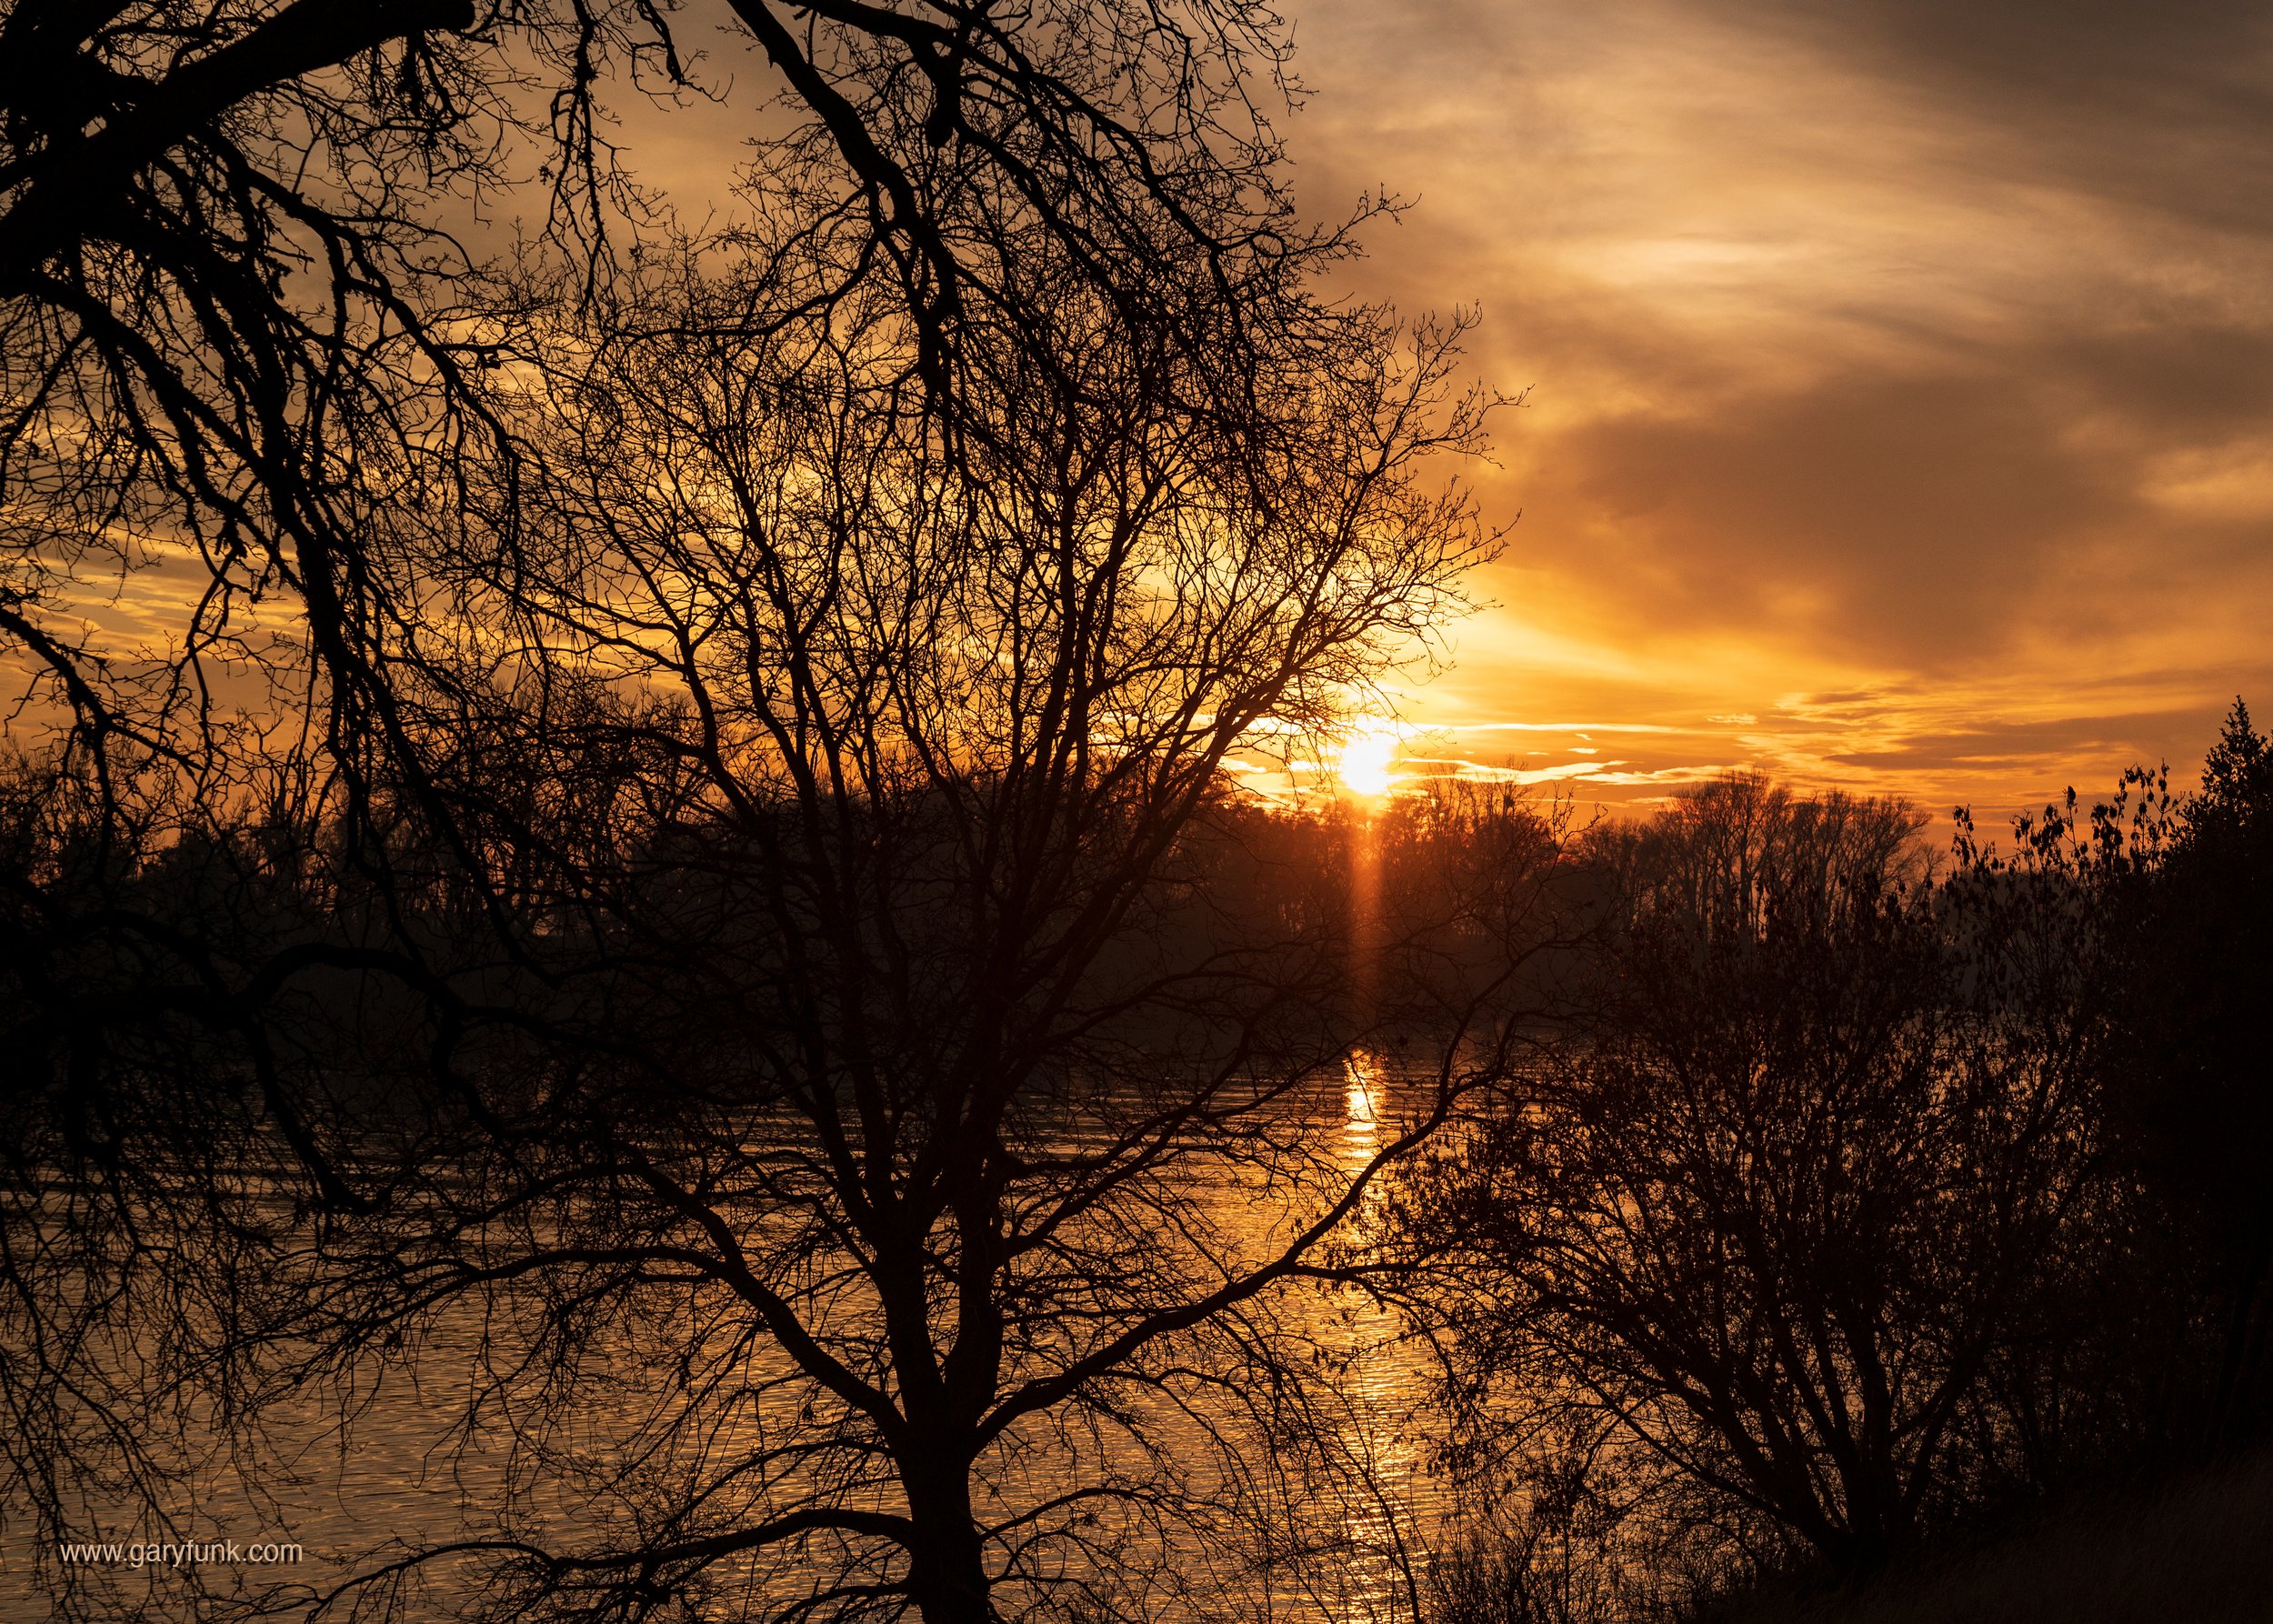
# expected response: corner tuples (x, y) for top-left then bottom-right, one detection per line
(1289, 0), (2273, 812)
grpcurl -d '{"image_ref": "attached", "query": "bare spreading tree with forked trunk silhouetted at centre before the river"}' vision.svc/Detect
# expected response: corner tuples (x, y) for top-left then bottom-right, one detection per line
(297, 215), (1489, 1619)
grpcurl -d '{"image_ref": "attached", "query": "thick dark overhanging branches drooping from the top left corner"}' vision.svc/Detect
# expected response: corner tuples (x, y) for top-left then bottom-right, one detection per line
(0, 0), (1330, 837)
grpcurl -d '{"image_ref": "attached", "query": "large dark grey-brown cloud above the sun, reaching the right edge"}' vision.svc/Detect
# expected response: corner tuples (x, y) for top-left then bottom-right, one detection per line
(1518, 288), (2273, 673)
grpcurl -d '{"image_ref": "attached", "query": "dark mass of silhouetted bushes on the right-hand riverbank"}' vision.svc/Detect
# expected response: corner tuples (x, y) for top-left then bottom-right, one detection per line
(1407, 703), (2273, 1619)
